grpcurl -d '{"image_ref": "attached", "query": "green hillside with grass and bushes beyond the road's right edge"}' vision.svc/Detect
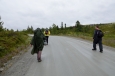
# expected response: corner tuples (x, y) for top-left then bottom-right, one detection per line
(50, 24), (115, 47)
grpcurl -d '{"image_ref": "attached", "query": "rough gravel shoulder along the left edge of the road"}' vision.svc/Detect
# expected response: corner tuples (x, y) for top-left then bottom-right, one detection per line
(0, 47), (33, 76)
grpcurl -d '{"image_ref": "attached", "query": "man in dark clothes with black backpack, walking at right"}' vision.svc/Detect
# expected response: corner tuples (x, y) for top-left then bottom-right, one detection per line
(92, 26), (104, 53)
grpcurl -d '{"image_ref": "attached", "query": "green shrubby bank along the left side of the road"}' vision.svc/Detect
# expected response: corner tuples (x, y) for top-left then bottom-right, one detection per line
(0, 31), (30, 66)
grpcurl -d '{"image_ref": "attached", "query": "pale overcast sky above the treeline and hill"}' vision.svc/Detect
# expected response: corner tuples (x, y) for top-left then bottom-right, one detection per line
(0, 0), (115, 30)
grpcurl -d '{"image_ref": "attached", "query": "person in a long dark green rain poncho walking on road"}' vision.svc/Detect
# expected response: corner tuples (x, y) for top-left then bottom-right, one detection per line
(30, 28), (45, 62)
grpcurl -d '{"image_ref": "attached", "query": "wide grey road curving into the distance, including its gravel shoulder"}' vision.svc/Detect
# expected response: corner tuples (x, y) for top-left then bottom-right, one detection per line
(0, 36), (115, 76)
